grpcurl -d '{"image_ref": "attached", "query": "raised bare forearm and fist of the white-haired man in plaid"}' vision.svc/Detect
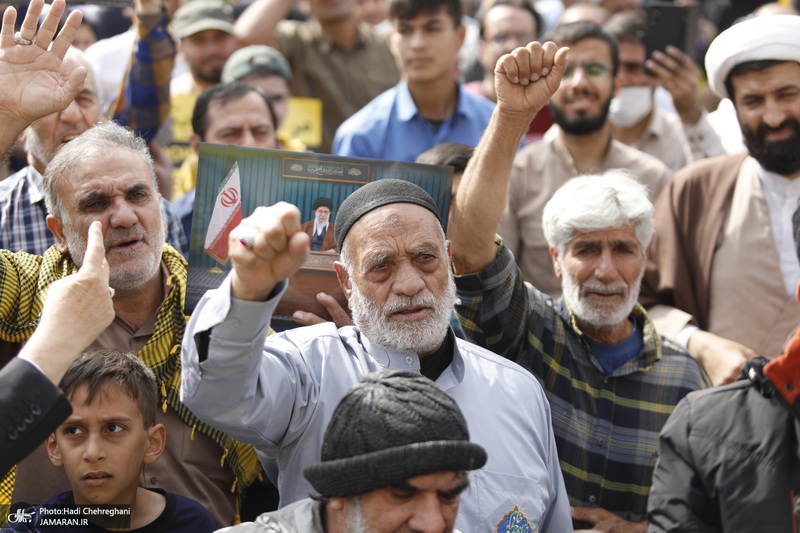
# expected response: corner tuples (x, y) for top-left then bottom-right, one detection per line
(448, 42), (569, 274)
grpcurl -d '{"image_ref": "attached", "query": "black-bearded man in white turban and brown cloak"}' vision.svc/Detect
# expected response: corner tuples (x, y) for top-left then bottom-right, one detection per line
(641, 15), (800, 384)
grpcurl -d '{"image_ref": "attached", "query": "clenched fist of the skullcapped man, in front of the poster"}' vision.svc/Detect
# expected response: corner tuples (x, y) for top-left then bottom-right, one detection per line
(228, 202), (311, 301)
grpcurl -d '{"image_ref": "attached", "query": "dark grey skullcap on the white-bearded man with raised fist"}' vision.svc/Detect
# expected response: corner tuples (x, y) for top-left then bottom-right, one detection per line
(333, 178), (442, 250)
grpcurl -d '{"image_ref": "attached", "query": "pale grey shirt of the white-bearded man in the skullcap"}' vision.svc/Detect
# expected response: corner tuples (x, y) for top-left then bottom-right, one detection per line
(181, 280), (572, 533)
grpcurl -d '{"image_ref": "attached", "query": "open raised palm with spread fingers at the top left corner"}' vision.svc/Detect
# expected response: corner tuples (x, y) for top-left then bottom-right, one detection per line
(0, 0), (86, 157)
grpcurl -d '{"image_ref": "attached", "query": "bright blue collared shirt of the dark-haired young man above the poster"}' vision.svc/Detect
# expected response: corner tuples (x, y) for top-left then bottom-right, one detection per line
(333, 82), (494, 163)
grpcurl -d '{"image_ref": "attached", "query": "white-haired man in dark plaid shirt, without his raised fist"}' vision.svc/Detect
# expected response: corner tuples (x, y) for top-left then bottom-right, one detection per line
(448, 58), (705, 532)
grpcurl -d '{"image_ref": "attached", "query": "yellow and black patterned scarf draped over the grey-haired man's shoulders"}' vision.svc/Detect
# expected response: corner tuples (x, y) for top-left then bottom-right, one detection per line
(0, 244), (261, 522)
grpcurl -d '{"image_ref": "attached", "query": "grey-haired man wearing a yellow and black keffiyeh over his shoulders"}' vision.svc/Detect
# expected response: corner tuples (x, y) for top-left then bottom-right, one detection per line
(0, 123), (261, 526)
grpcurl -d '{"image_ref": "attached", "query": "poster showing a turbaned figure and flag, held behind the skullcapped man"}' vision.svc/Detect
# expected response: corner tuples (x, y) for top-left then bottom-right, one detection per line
(186, 143), (453, 328)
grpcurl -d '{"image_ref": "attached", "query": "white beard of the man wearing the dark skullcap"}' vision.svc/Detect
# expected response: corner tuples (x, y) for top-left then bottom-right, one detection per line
(350, 276), (456, 353)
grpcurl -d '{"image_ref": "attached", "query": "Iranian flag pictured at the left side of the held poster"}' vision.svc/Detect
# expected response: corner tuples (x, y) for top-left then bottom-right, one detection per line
(204, 162), (242, 265)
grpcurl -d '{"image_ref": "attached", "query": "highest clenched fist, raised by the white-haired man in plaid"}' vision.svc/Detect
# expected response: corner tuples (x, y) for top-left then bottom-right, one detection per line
(494, 41), (569, 116)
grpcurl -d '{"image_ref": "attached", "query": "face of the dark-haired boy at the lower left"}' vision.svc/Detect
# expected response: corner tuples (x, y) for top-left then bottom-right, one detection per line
(47, 384), (166, 505)
